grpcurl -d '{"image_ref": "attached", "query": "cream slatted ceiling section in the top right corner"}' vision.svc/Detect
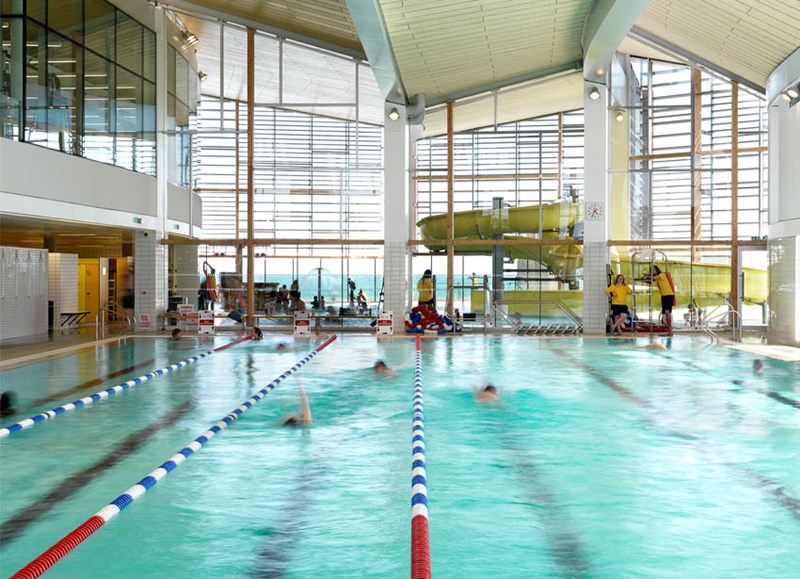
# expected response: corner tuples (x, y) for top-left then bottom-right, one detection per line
(636, 0), (800, 86)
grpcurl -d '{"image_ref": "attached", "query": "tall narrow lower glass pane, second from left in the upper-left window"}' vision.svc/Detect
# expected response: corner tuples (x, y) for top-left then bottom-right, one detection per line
(23, 18), (47, 145)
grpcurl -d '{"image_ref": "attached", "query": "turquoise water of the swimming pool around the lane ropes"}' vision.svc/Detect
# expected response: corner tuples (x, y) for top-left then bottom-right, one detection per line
(0, 336), (800, 579)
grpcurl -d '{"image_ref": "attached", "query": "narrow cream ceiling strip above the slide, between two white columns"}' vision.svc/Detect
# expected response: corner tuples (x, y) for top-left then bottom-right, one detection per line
(424, 72), (583, 137)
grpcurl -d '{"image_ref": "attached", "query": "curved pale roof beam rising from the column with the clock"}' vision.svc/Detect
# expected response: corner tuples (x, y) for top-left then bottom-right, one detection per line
(582, 0), (650, 84)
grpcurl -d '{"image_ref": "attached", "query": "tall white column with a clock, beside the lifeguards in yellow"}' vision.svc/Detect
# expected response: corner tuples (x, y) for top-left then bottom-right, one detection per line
(583, 81), (609, 334)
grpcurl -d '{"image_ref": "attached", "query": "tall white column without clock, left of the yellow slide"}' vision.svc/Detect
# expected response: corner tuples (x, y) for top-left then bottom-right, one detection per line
(383, 103), (411, 332)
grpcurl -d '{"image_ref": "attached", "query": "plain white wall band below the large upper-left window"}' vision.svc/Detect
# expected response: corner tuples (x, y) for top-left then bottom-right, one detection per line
(0, 139), (156, 218)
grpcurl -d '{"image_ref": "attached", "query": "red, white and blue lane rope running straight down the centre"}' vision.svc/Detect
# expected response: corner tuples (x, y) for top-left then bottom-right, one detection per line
(411, 336), (431, 579)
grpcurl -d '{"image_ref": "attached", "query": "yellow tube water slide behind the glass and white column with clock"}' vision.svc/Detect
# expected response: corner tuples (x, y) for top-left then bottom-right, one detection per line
(417, 201), (767, 308)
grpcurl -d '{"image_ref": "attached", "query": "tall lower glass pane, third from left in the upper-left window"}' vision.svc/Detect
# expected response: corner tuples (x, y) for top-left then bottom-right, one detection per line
(47, 34), (81, 153)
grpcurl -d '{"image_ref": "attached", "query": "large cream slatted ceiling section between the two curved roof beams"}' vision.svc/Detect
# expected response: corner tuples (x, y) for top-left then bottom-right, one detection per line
(380, 0), (593, 101)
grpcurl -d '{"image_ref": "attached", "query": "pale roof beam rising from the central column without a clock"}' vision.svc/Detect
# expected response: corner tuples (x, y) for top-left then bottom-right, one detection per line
(347, 0), (408, 106)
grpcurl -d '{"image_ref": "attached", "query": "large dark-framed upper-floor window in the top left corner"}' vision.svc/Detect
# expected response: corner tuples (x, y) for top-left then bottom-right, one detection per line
(0, 0), (156, 175)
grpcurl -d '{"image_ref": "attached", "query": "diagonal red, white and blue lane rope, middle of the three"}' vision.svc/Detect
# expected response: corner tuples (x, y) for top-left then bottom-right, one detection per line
(11, 334), (336, 579)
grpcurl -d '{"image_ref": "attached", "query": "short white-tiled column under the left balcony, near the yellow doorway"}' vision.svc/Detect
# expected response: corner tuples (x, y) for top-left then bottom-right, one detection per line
(133, 231), (167, 332)
